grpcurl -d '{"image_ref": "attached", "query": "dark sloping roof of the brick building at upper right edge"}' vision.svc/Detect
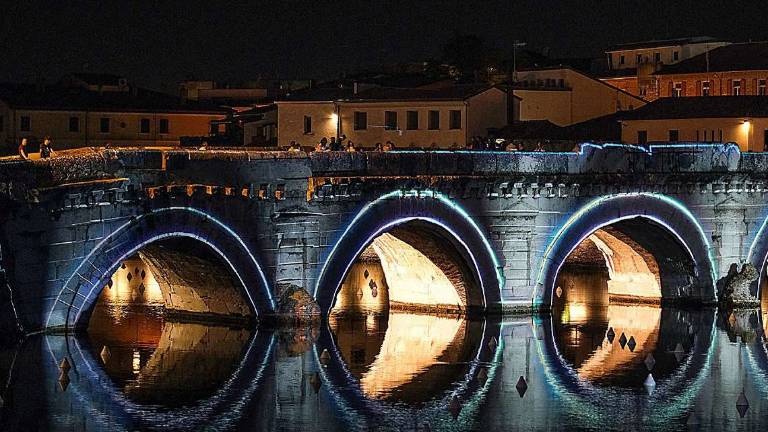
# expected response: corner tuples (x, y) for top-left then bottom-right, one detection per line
(656, 42), (768, 75)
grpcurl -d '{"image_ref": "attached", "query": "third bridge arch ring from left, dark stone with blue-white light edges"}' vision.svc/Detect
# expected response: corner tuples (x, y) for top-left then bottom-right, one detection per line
(533, 193), (717, 308)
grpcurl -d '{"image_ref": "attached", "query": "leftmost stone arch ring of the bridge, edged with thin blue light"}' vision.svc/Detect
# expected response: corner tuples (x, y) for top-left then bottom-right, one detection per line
(46, 207), (276, 328)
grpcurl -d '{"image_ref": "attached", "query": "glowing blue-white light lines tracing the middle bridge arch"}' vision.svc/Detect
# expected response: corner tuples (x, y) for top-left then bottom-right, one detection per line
(313, 189), (504, 307)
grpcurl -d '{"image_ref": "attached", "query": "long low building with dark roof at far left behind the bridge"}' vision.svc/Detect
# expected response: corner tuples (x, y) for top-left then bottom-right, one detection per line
(0, 75), (227, 153)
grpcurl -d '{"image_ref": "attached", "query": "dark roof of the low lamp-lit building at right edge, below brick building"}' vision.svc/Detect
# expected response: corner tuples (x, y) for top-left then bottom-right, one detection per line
(623, 96), (768, 120)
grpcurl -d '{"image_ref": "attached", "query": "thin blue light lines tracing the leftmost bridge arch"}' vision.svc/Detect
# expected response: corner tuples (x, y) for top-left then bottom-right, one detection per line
(45, 206), (276, 328)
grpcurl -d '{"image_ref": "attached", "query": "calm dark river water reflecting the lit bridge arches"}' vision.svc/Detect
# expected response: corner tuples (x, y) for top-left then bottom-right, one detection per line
(0, 276), (768, 431)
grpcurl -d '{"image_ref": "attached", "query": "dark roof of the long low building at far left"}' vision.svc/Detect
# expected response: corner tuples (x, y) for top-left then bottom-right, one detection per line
(0, 83), (227, 114)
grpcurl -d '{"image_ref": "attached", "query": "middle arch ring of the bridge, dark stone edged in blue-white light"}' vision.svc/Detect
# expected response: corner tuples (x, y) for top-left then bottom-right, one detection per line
(314, 190), (503, 315)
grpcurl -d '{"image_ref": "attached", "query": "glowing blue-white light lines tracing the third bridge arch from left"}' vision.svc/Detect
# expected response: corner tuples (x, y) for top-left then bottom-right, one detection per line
(532, 192), (717, 304)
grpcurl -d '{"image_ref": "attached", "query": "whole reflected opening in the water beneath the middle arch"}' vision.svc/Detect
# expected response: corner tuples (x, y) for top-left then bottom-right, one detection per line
(331, 312), (483, 403)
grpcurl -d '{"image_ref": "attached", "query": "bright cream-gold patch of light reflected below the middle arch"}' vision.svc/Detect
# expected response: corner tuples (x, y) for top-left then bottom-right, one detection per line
(360, 312), (463, 398)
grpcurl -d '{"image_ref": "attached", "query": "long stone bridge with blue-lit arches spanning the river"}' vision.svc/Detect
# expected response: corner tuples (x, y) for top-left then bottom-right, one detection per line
(0, 143), (768, 332)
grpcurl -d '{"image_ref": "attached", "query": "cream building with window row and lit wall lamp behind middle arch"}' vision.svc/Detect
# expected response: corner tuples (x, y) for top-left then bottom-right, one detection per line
(276, 86), (507, 148)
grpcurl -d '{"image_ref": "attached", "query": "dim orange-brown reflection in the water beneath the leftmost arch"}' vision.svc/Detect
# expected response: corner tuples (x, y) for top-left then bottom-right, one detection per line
(87, 296), (251, 408)
